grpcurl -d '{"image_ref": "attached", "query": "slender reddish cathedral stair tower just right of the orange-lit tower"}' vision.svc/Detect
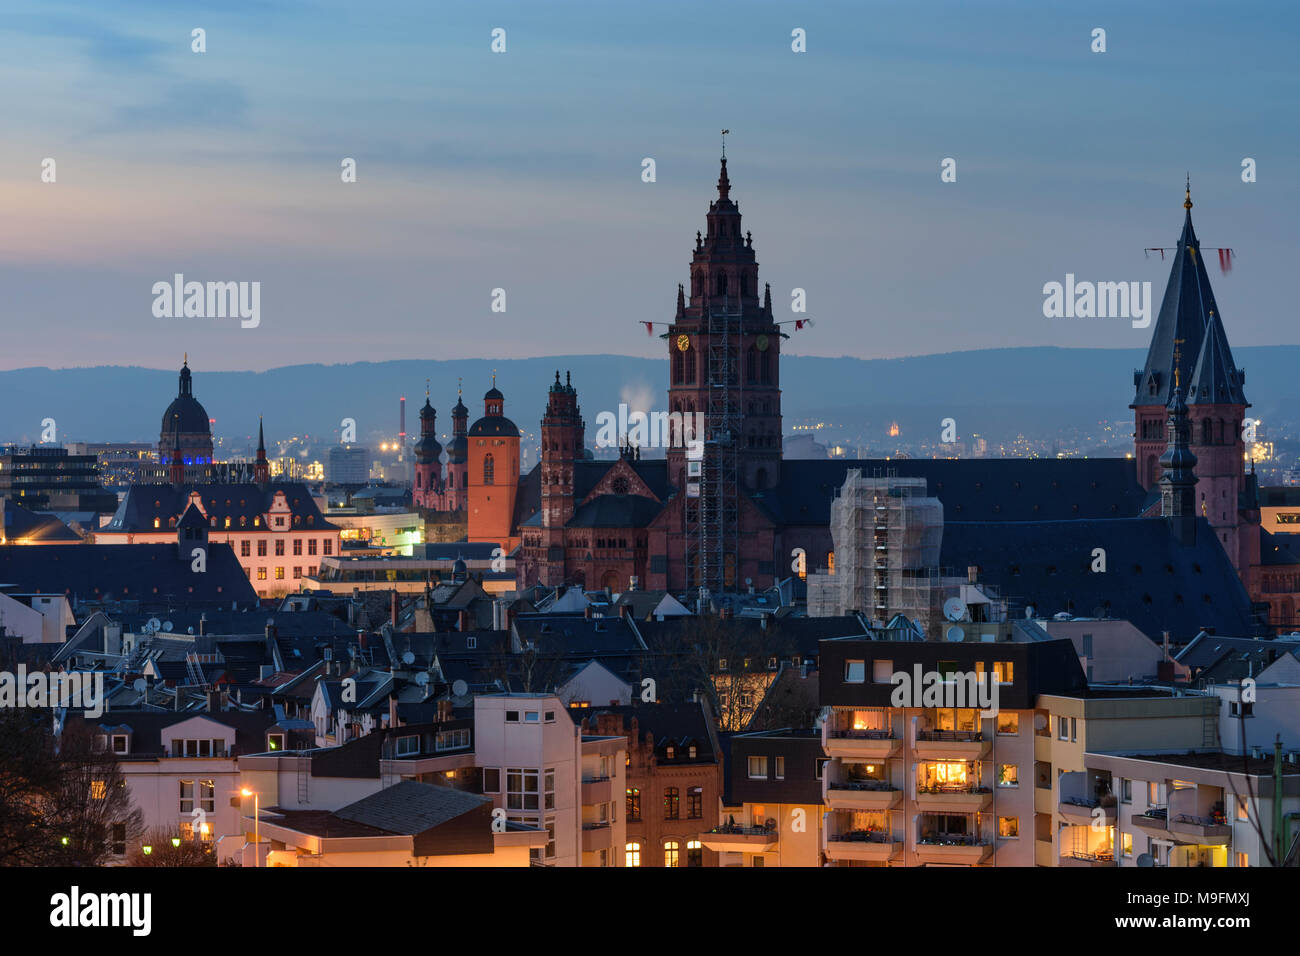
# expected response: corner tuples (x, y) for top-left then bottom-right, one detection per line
(537, 371), (585, 587)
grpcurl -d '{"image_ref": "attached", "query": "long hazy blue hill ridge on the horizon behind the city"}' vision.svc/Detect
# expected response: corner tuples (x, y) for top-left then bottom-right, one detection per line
(0, 346), (1300, 449)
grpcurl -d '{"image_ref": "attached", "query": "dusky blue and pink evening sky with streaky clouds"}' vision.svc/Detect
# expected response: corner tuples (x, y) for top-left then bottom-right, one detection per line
(0, 3), (1297, 371)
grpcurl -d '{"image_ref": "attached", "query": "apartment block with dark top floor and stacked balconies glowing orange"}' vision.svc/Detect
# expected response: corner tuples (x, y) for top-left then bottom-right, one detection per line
(820, 634), (1087, 866)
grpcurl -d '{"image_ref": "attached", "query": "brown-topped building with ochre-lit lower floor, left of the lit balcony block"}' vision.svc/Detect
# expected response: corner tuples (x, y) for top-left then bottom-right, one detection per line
(698, 728), (826, 866)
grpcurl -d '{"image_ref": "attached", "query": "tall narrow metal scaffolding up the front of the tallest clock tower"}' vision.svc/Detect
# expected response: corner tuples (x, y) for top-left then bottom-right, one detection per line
(685, 299), (744, 597)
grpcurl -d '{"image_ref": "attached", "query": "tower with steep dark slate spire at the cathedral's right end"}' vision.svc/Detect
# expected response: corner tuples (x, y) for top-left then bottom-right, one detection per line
(1130, 185), (1260, 589)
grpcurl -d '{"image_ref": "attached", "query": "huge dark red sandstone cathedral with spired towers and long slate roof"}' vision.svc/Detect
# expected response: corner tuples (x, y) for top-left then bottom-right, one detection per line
(444, 157), (1300, 640)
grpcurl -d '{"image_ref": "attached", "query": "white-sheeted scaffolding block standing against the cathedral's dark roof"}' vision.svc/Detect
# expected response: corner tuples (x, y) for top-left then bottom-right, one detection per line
(809, 470), (944, 636)
